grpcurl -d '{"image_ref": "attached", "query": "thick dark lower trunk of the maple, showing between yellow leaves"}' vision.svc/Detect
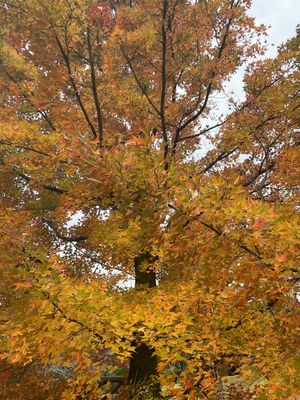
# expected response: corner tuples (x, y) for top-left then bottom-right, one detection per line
(129, 252), (160, 400)
